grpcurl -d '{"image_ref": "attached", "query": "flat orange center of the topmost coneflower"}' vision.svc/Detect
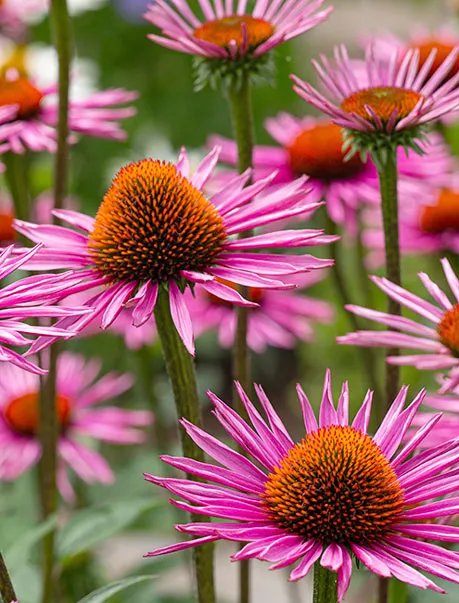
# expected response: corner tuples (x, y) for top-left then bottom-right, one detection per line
(193, 15), (274, 50)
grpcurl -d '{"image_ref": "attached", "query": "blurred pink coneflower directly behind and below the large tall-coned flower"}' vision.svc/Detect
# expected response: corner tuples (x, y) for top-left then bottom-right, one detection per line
(187, 273), (334, 353)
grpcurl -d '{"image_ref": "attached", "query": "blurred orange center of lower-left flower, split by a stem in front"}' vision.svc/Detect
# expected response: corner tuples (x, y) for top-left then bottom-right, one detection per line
(3, 392), (71, 435)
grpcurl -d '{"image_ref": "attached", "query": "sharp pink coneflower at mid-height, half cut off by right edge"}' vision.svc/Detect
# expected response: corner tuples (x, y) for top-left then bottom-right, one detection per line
(337, 259), (459, 390)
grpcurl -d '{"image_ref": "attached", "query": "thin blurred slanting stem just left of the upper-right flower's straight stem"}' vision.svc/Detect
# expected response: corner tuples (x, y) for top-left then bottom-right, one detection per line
(325, 211), (382, 410)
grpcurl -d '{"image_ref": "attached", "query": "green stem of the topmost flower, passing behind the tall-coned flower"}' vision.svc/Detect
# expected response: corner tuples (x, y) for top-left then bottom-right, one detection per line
(228, 73), (254, 603)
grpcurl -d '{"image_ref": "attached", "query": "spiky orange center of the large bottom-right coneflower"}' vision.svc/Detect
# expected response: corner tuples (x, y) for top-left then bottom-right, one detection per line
(264, 425), (404, 545)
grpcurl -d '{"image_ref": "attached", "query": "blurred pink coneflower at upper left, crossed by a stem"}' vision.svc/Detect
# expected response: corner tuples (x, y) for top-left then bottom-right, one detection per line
(0, 69), (137, 153)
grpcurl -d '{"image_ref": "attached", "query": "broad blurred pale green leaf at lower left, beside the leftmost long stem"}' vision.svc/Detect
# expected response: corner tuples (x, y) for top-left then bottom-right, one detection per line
(57, 499), (163, 563)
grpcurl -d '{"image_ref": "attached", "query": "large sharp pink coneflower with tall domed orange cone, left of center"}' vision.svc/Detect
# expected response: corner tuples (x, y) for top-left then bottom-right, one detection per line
(14, 149), (334, 353)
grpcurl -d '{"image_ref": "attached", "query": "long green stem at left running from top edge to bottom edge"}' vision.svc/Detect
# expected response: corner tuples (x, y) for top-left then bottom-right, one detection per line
(39, 0), (71, 603)
